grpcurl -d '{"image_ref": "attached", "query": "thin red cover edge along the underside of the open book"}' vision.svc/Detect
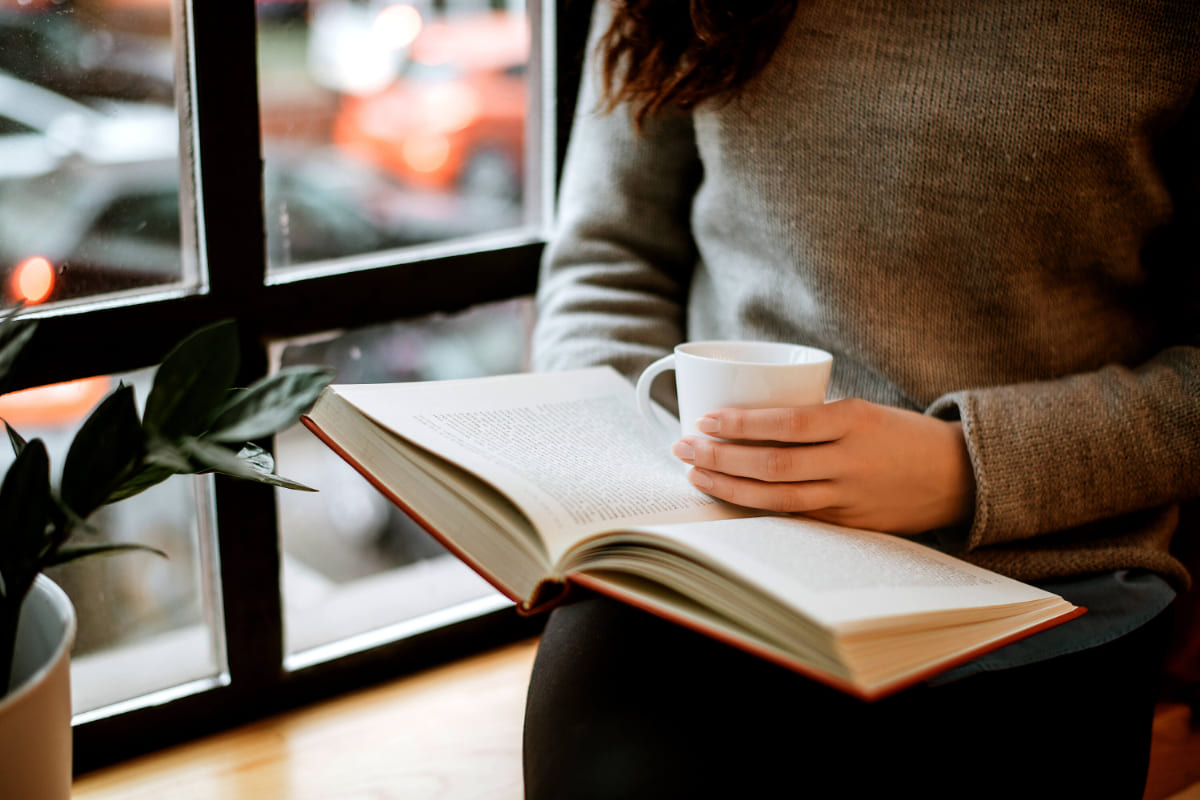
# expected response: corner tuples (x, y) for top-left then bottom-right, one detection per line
(300, 414), (1087, 700)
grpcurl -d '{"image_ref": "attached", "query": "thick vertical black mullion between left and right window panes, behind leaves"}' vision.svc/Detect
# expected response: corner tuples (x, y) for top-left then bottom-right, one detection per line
(191, 2), (283, 698)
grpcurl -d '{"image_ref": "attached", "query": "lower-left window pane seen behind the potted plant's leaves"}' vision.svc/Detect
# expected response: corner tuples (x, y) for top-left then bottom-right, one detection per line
(0, 369), (224, 715)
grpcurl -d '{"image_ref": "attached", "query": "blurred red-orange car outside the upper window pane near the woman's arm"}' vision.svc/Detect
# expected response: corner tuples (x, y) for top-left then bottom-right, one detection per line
(332, 11), (529, 201)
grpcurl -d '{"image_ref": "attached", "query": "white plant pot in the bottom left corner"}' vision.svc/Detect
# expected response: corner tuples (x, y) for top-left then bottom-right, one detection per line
(0, 575), (76, 800)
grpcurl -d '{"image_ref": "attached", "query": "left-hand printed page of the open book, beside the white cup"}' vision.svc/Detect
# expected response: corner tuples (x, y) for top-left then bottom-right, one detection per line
(337, 368), (748, 561)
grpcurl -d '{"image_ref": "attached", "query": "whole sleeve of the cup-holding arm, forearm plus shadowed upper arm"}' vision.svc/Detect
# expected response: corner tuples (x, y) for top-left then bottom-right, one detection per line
(929, 87), (1200, 549)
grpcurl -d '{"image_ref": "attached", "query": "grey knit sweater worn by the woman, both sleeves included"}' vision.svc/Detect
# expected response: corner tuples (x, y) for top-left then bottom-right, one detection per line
(534, 0), (1200, 585)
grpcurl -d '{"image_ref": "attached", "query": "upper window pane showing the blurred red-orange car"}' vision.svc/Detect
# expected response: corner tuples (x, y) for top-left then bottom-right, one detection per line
(258, 0), (533, 270)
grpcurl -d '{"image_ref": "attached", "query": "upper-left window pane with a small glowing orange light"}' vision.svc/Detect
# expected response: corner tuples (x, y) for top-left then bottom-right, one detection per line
(0, 0), (189, 305)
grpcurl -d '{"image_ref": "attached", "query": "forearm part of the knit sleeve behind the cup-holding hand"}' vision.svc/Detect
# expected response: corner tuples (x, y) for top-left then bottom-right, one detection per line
(930, 347), (1200, 549)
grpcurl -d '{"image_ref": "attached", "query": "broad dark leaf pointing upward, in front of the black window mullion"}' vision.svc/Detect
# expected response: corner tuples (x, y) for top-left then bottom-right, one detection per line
(143, 320), (239, 439)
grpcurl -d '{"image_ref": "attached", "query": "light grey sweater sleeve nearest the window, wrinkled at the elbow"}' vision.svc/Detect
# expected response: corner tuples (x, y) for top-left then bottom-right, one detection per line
(533, 2), (701, 378)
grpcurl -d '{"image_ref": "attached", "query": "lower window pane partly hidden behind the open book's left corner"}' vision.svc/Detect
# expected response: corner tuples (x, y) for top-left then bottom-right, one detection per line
(276, 301), (532, 667)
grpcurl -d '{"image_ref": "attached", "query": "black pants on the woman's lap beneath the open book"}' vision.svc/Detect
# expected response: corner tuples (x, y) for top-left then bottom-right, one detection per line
(524, 597), (1170, 800)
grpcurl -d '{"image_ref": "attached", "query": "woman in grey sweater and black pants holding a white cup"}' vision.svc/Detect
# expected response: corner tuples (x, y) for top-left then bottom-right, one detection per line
(526, 0), (1200, 798)
